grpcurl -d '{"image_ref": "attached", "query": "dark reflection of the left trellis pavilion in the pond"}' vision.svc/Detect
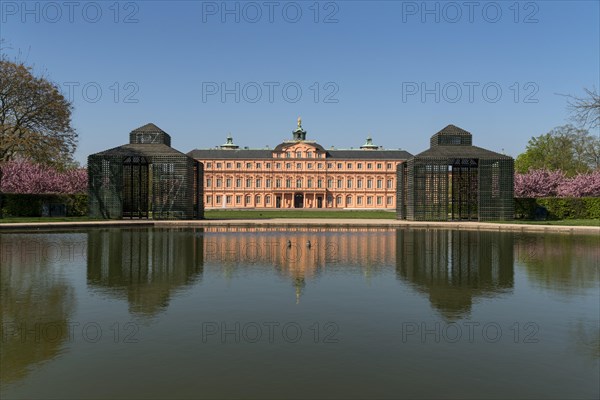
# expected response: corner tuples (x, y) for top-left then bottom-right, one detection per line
(87, 229), (204, 315)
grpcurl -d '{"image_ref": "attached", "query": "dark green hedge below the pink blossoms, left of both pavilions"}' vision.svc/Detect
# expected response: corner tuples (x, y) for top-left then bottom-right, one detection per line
(1, 193), (88, 217)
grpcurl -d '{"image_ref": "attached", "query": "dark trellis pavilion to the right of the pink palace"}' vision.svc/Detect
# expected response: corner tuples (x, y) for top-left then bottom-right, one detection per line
(396, 125), (514, 221)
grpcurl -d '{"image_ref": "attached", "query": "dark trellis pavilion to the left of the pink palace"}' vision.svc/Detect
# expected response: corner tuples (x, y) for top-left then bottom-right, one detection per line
(88, 124), (204, 219)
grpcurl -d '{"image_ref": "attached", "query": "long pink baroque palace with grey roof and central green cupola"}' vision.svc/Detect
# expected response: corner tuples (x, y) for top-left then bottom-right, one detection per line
(188, 118), (412, 210)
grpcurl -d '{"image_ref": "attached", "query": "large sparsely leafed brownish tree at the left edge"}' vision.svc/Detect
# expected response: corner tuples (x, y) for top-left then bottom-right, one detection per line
(0, 57), (77, 168)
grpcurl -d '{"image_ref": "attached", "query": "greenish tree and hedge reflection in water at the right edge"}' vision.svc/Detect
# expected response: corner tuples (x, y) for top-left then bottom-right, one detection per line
(515, 234), (600, 294)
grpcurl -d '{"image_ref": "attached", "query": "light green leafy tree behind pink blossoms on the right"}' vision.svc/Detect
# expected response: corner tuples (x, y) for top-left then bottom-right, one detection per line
(515, 125), (600, 176)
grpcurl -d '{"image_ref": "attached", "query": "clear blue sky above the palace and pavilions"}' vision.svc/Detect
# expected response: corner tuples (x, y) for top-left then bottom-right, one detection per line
(0, 1), (600, 164)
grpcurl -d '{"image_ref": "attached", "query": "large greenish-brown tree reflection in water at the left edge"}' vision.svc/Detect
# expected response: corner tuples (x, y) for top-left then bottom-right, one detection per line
(0, 234), (79, 384)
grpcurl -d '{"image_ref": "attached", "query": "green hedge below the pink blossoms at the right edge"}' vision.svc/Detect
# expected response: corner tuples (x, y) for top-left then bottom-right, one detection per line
(515, 197), (600, 219)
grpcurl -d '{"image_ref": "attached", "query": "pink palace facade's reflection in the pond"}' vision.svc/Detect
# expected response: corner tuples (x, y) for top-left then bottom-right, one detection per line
(204, 227), (395, 300)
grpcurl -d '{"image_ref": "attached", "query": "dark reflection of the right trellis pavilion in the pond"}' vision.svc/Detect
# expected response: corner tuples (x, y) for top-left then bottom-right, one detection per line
(396, 229), (514, 319)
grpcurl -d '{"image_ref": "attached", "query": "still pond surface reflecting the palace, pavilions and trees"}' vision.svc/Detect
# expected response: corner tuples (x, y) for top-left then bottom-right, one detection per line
(0, 227), (600, 399)
